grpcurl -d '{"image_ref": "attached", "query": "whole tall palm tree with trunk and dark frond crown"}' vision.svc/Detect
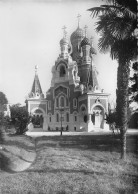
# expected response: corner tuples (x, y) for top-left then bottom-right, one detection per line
(88, 0), (137, 159)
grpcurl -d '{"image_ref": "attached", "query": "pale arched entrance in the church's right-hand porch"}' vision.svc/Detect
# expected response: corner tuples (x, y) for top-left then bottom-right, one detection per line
(92, 106), (104, 128)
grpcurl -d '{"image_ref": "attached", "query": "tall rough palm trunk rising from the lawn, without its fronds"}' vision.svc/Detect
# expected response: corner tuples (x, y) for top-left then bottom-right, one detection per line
(116, 57), (130, 159)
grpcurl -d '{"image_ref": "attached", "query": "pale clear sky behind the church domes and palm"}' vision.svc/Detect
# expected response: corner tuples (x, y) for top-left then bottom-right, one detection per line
(0, 0), (117, 104)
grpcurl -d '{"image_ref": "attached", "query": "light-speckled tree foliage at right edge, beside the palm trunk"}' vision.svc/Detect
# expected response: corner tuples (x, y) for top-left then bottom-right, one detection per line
(129, 62), (138, 102)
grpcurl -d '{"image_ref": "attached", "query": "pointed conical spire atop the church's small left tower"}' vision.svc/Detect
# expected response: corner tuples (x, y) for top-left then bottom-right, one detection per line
(31, 65), (43, 96)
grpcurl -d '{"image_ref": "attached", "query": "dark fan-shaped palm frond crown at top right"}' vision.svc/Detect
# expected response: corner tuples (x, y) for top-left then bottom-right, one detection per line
(89, 0), (137, 61)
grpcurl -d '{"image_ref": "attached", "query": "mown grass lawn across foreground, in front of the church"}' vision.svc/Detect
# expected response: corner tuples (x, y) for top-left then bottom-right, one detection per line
(0, 135), (138, 194)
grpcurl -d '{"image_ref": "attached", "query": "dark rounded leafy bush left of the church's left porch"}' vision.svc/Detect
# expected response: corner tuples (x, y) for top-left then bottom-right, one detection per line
(10, 104), (29, 134)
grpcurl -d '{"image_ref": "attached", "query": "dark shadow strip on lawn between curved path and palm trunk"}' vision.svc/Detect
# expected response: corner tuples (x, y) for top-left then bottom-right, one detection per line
(36, 135), (118, 150)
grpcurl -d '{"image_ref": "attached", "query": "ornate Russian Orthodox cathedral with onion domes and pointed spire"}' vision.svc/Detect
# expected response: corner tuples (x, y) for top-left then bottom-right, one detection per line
(26, 17), (109, 132)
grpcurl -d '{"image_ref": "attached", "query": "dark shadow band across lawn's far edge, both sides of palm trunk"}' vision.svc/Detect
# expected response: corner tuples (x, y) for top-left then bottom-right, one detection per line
(36, 135), (138, 153)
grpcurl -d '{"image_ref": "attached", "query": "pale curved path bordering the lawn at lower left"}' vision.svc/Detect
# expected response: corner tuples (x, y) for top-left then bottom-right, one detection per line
(0, 137), (36, 173)
